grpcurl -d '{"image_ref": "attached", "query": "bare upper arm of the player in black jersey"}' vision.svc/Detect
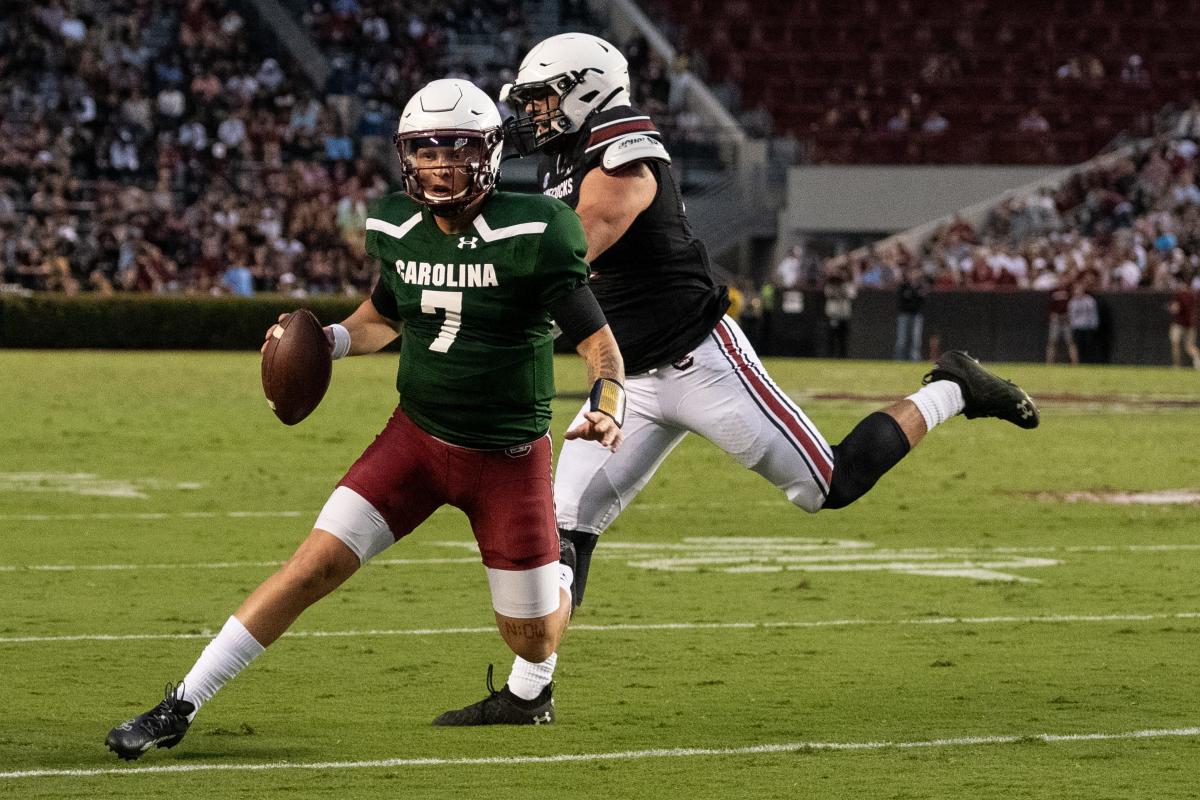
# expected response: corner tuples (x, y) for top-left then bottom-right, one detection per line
(575, 161), (659, 264)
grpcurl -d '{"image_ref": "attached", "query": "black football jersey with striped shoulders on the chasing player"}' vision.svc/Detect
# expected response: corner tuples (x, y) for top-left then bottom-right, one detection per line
(538, 106), (730, 374)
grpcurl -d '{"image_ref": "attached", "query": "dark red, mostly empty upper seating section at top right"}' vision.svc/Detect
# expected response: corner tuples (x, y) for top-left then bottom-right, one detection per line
(655, 0), (1200, 163)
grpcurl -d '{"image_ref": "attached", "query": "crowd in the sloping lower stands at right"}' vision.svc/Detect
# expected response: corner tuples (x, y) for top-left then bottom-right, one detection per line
(824, 134), (1200, 303)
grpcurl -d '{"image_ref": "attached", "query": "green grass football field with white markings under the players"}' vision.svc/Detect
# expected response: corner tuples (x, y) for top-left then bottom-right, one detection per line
(0, 351), (1200, 800)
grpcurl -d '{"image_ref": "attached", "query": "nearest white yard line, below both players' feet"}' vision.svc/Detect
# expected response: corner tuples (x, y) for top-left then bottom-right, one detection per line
(0, 727), (1200, 780)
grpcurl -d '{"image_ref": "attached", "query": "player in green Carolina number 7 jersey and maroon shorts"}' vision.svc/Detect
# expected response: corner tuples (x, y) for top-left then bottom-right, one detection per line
(107, 80), (624, 759)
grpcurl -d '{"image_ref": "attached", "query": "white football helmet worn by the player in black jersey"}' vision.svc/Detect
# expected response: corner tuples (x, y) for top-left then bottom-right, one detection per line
(500, 34), (630, 156)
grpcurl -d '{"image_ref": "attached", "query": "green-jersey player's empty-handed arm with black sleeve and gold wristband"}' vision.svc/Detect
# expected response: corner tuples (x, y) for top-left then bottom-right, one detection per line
(550, 284), (625, 452)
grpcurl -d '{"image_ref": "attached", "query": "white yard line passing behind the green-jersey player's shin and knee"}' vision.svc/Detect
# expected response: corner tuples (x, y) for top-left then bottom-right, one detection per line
(0, 612), (1200, 644)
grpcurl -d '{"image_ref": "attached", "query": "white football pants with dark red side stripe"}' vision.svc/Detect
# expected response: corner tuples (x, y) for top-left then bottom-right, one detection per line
(554, 317), (833, 534)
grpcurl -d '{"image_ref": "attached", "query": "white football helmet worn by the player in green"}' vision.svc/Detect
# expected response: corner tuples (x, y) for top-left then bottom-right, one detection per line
(392, 78), (504, 217)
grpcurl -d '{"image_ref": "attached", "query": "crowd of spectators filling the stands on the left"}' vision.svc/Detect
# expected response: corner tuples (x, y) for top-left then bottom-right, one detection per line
(0, 0), (720, 295)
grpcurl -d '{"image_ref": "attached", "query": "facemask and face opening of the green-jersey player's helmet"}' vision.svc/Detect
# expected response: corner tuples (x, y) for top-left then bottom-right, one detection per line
(394, 128), (502, 217)
